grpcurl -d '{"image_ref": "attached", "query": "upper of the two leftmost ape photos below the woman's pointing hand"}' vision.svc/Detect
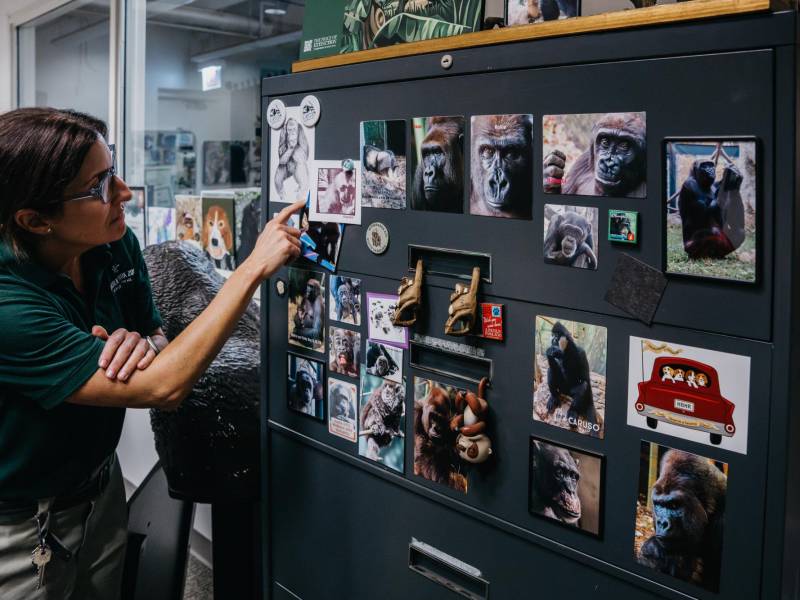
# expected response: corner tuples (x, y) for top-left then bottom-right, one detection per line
(288, 267), (325, 352)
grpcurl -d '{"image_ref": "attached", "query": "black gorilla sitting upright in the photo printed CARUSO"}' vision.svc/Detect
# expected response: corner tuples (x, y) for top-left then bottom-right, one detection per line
(545, 322), (597, 427)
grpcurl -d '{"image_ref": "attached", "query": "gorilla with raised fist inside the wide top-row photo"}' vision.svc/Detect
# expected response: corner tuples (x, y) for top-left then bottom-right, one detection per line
(544, 113), (647, 198)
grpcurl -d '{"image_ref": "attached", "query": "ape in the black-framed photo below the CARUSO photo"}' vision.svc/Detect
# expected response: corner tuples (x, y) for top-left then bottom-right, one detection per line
(530, 440), (581, 527)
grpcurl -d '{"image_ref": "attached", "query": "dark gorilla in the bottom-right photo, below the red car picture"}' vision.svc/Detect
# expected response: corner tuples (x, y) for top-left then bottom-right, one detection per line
(637, 450), (728, 591)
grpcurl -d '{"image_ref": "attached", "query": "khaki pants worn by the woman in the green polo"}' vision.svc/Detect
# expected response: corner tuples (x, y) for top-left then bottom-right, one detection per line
(0, 461), (128, 600)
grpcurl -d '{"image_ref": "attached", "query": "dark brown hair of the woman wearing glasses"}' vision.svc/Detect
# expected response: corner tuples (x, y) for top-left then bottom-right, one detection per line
(0, 108), (108, 258)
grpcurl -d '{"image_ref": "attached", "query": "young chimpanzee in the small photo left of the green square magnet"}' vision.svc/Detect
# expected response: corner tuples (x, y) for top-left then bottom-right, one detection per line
(543, 210), (598, 269)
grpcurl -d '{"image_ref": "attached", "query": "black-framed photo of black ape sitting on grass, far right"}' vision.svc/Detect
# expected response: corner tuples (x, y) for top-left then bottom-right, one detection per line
(666, 138), (758, 283)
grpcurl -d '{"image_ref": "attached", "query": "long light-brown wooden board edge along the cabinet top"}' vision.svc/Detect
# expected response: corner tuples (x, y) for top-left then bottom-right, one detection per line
(292, 0), (785, 73)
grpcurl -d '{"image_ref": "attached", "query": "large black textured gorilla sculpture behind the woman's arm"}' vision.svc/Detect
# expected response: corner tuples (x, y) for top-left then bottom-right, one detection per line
(144, 242), (260, 502)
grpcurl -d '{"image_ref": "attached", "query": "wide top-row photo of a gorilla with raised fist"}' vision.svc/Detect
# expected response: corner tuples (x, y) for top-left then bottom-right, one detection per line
(542, 112), (647, 198)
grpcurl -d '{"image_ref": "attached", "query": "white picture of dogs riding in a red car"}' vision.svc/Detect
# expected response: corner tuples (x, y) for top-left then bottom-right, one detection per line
(627, 336), (750, 454)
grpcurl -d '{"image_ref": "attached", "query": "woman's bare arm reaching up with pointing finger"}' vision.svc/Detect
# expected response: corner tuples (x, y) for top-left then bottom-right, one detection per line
(67, 201), (305, 408)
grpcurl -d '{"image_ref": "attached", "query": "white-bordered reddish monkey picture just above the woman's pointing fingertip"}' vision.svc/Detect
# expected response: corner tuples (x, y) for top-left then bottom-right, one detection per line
(308, 160), (361, 225)
